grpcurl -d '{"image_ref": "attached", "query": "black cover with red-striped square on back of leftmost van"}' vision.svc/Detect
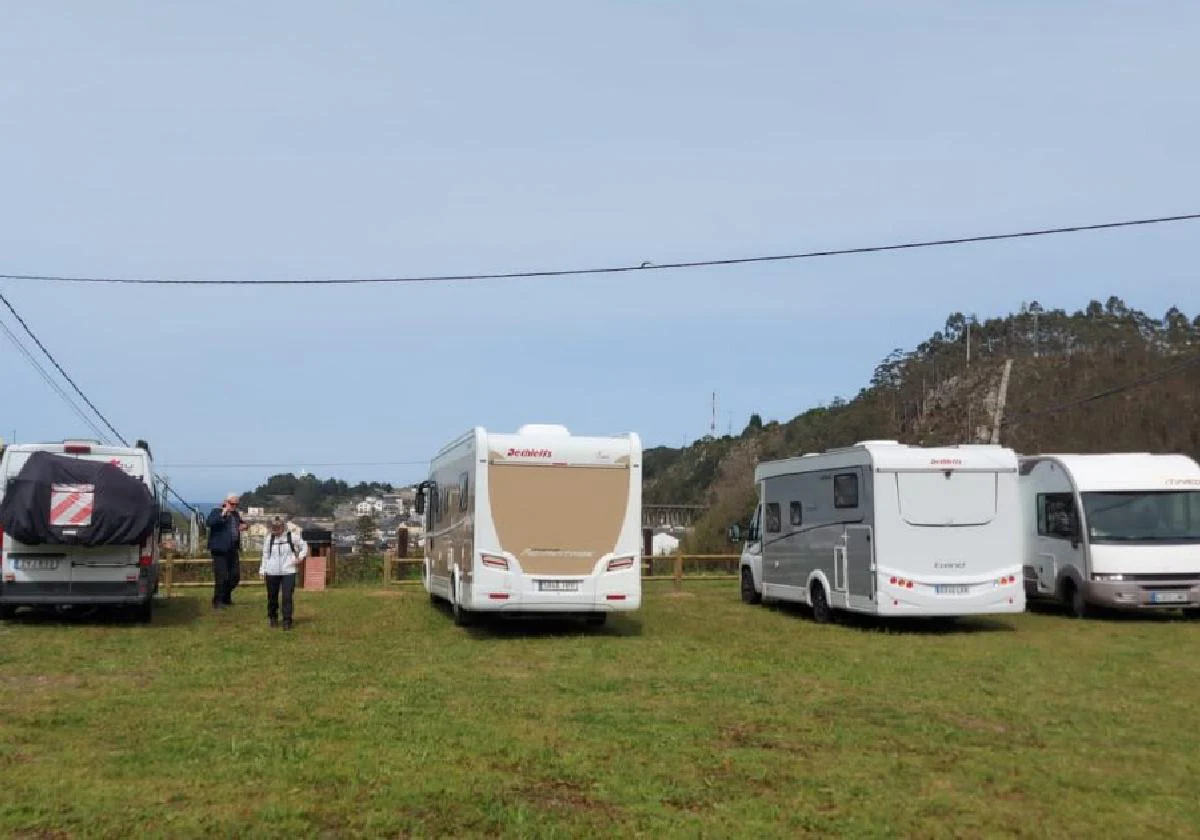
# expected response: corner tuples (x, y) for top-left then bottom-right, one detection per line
(0, 452), (158, 546)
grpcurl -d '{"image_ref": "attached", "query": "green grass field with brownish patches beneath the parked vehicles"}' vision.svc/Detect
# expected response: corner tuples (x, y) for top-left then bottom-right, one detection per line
(0, 582), (1200, 838)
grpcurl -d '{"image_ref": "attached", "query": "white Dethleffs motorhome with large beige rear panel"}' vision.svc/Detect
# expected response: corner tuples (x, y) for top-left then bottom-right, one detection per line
(416, 425), (642, 624)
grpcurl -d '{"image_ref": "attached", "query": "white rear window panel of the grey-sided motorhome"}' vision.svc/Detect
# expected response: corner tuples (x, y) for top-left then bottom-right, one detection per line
(895, 470), (1000, 527)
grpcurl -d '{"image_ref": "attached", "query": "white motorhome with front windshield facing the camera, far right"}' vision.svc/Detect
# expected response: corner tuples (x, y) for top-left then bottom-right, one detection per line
(1020, 452), (1200, 618)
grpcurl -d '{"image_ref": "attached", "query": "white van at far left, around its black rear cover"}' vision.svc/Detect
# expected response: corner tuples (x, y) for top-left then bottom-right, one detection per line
(0, 440), (173, 622)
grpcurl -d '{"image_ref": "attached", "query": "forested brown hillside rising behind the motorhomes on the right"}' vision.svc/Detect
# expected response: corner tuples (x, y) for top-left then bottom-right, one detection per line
(644, 298), (1200, 551)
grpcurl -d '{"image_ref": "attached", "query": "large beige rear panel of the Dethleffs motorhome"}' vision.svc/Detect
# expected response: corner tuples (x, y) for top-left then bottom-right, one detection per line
(487, 463), (629, 575)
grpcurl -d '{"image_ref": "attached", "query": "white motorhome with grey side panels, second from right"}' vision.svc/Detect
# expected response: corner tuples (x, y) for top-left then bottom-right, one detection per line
(730, 440), (1025, 623)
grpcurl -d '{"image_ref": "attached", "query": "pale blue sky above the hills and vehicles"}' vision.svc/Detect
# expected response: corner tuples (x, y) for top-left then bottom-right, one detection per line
(0, 0), (1200, 499)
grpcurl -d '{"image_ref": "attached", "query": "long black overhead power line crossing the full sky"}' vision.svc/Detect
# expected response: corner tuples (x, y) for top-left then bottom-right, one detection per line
(0, 212), (1200, 286)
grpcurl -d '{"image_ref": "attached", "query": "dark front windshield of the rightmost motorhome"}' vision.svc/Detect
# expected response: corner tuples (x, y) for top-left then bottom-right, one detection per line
(1082, 490), (1200, 542)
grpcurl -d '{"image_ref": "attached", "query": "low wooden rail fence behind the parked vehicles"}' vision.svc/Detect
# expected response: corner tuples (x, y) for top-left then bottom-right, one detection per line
(162, 554), (738, 598)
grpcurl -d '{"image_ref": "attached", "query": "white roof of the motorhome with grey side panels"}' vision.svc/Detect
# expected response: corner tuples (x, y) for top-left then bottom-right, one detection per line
(755, 440), (1016, 481)
